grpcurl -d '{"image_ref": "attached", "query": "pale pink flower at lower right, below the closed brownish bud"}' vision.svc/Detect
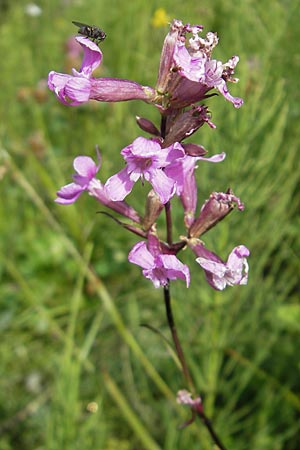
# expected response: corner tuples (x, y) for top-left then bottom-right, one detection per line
(189, 240), (250, 291)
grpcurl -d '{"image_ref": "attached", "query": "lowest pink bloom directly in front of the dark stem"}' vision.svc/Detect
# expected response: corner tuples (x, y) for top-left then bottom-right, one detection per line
(128, 233), (190, 288)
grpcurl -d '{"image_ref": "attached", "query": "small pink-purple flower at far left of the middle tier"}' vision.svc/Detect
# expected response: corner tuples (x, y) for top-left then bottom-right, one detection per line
(55, 153), (101, 205)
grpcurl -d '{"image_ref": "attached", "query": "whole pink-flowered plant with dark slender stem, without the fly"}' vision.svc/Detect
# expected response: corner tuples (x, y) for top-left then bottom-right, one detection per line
(48, 20), (249, 449)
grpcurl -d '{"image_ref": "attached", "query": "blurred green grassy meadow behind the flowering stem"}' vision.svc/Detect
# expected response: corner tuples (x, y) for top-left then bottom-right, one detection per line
(0, 0), (300, 450)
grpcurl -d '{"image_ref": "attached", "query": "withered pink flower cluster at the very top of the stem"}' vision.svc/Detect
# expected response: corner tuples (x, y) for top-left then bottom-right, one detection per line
(156, 20), (243, 109)
